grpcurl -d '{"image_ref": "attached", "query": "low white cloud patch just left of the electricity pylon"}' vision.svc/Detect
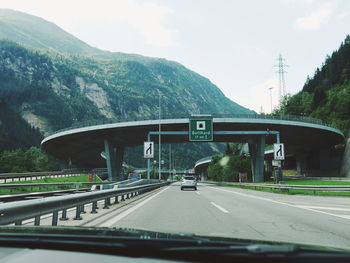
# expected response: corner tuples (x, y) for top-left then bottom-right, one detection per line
(236, 76), (278, 113)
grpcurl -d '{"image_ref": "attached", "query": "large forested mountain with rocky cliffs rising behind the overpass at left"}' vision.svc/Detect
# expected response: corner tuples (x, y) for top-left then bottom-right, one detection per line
(0, 10), (253, 167)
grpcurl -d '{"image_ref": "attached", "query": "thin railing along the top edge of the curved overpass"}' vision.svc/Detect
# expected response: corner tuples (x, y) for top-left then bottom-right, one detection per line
(50, 113), (337, 135)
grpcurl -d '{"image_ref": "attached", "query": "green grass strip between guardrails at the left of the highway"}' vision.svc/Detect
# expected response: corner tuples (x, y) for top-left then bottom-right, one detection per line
(0, 174), (101, 195)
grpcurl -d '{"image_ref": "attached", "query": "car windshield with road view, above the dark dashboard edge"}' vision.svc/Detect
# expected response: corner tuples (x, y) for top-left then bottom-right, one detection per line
(0, 0), (350, 254)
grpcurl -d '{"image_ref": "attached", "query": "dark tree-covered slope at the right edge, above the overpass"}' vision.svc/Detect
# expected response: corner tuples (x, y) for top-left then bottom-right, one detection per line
(278, 36), (350, 136)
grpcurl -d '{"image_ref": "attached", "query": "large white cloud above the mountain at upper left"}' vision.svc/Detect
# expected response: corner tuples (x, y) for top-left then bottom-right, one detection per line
(0, 0), (177, 47)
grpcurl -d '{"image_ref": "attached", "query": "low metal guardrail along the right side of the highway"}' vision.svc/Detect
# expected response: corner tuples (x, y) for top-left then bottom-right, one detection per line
(218, 182), (350, 192)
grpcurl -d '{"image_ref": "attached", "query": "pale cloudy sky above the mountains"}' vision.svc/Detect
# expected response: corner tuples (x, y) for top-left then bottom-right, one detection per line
(0, 0), (350, 113)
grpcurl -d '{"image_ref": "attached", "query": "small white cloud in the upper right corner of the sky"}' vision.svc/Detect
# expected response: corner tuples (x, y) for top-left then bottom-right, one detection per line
(295, 4), (334, 30)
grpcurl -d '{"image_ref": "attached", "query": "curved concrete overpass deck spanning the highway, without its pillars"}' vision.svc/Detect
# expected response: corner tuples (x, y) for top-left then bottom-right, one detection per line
(41, 115), (344, 171)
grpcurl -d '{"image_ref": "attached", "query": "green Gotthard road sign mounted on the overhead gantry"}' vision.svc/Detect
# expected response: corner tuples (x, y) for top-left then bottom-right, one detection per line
(189, 116), (213, 142)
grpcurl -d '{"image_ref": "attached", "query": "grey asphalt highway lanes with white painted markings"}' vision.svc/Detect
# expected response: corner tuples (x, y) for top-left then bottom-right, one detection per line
(94, 183), (350, 248)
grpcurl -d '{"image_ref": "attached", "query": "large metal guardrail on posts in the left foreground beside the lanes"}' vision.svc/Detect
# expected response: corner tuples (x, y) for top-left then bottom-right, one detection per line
(0, 183), (167, 226)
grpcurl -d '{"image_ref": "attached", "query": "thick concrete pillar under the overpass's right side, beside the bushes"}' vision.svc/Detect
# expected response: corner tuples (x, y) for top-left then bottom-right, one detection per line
(248, 135), (265, 183)
